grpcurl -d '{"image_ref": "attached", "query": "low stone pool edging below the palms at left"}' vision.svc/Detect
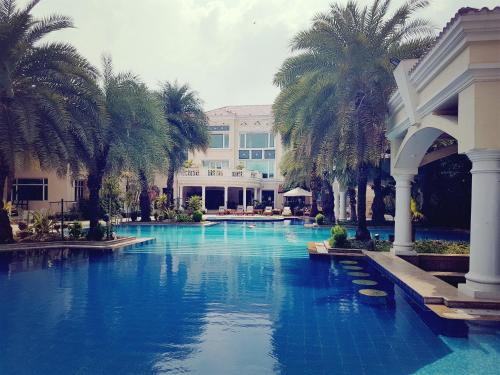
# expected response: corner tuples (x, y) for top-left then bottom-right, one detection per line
(0, 237), (156, 254)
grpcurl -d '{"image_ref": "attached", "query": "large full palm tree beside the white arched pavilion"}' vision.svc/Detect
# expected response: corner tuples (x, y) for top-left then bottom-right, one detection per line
(275, 0), (435, 239)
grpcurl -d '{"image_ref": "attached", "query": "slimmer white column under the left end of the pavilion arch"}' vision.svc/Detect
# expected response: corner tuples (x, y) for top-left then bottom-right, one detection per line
(391, 174), (416, 255)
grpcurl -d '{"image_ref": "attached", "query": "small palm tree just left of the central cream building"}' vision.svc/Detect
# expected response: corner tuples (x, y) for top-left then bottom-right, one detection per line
(159, 82), (209, 206)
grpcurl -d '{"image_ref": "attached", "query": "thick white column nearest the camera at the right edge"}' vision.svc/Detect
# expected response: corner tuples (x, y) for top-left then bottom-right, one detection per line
(458, 150), (500, 299)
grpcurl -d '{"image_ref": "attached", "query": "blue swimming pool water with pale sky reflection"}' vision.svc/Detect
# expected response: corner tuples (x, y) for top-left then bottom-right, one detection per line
(0, 223), (500, 375)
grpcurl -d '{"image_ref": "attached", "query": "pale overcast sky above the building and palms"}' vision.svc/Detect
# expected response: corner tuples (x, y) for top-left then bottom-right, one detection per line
(26, 0), (499, 110)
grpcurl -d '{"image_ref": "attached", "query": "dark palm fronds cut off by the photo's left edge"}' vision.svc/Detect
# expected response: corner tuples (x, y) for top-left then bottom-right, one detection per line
(0, 0), (97, 199)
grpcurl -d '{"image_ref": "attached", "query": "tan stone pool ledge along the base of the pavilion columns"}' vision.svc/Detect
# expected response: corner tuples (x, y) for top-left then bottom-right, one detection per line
(308, 242), (500, 321)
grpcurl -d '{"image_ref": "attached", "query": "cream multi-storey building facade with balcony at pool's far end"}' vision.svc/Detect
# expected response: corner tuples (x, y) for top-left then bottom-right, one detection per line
(170, 105), (283, 211)
